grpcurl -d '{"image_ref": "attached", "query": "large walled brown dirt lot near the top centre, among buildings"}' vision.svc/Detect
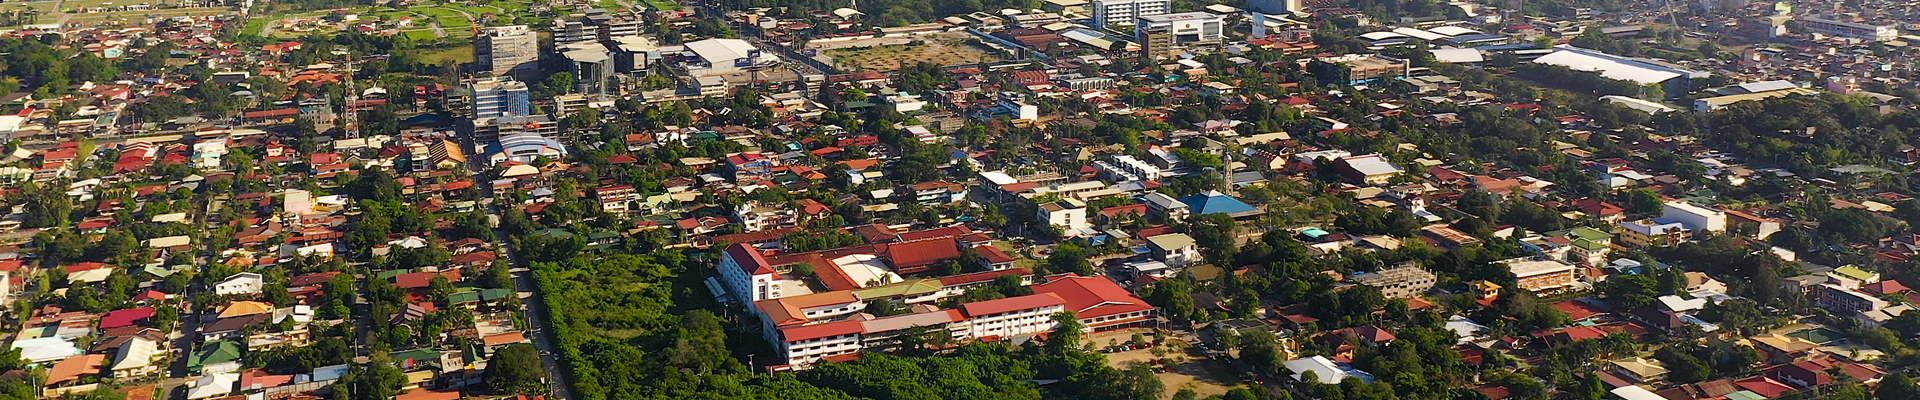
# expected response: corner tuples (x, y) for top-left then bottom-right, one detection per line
(812, 33), (1000, 71)
